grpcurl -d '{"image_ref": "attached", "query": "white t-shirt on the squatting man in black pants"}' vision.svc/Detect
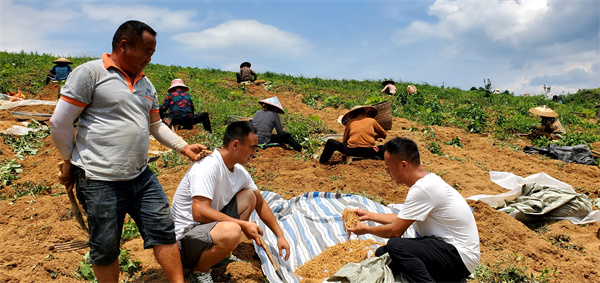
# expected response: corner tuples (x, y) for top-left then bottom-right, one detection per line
(398, 173), (480, 272)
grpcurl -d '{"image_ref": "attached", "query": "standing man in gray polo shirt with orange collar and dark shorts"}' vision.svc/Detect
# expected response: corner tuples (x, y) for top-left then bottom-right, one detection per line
(50, 20), (206, 282)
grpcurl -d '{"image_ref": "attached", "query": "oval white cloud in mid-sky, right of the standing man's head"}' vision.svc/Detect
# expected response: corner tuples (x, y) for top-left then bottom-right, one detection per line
(173, 20), (311, 58)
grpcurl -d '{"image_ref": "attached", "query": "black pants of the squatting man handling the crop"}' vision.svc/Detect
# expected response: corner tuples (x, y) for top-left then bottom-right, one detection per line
(375, 237), (471, 282)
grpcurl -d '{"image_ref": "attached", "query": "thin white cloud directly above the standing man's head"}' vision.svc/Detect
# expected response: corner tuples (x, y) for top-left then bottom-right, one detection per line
(82, 4), (196, 30)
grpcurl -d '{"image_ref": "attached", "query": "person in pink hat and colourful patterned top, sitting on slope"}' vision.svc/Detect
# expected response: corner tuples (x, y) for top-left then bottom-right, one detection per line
(159, 79), (212, 133)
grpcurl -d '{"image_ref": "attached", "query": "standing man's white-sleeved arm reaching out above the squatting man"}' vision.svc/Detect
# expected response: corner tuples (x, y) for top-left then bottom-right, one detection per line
(150, 112), (212, 161)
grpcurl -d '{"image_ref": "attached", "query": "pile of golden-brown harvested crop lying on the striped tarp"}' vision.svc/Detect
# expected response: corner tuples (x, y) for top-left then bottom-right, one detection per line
(296, 240), (381, 282)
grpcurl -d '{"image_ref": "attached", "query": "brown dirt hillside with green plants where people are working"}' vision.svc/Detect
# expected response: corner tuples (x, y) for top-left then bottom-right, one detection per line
(0, 53), (600, 282)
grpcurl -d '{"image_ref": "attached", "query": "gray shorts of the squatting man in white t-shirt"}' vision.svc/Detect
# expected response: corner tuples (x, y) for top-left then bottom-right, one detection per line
(177, 197), (240, 268)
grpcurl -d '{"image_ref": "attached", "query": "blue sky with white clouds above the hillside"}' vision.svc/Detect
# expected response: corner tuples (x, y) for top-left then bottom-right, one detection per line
(0, 0), (600, 95)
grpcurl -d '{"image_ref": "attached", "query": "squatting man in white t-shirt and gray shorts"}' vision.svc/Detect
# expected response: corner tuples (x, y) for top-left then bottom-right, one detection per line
(171, 121), (290, 276)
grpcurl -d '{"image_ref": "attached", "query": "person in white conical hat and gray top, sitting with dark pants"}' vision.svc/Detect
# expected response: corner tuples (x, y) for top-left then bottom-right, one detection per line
(252, 96), (302, 152)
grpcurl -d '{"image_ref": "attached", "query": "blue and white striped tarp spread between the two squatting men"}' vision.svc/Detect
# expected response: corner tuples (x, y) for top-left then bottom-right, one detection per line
(250, 192), (416, 282)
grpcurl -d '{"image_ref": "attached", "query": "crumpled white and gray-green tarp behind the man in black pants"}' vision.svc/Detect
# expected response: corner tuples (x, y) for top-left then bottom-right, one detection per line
(467, 171), (600, 224)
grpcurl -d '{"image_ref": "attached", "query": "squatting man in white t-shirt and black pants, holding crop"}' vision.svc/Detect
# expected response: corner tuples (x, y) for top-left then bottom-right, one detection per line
(348, 137), (480, 282)
